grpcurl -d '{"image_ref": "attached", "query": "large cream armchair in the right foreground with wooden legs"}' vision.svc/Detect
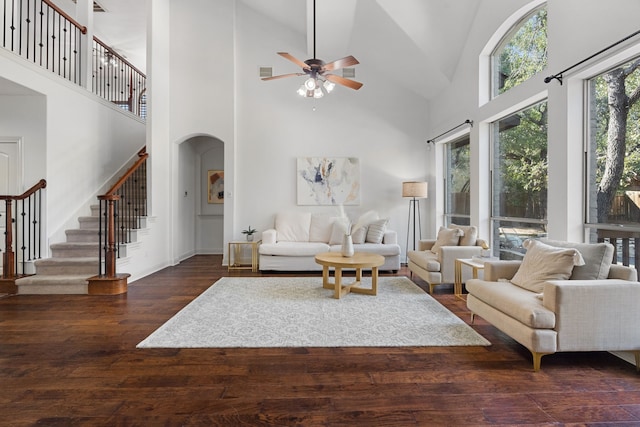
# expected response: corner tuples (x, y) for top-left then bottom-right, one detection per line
(467, 240), (640, 371)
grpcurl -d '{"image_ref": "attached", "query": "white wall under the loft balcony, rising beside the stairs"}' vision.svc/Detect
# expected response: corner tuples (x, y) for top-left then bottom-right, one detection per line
(0, 49), (145, 251)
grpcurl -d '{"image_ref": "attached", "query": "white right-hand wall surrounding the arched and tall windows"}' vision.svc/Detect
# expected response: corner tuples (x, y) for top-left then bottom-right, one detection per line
(428, 0), (640, 246)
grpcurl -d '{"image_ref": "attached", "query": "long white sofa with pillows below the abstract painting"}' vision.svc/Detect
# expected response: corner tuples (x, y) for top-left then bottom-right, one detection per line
(259, 212), (400, 271)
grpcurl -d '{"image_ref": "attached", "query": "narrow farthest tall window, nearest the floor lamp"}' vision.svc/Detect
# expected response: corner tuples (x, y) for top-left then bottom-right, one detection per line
(444, 135), (471, 225)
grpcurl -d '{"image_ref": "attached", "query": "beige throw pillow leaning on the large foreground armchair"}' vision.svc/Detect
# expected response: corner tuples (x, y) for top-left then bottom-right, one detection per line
(511, 239), (584, 293)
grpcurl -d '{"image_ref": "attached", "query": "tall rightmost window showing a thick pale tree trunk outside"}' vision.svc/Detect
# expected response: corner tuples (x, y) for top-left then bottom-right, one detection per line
(587, 58), (640, 268)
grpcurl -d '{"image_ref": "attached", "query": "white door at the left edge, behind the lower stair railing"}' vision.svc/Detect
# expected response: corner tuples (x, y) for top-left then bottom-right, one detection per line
(0, 137), (22, 271)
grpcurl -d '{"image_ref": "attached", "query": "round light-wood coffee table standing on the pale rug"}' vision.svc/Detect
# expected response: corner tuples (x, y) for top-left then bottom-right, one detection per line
(316, 252), (384, 299)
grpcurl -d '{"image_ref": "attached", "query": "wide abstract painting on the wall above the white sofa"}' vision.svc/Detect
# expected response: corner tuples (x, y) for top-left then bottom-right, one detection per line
(297, 157), (360, 205)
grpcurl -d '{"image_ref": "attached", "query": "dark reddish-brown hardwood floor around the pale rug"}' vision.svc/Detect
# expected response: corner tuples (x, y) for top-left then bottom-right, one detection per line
(0, 256), (640, 426)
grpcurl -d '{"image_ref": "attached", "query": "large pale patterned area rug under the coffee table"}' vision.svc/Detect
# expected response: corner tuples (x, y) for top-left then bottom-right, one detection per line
(137, 277), (491, 348)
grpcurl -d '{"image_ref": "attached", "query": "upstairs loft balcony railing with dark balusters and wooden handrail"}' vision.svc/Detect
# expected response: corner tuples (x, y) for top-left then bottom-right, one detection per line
(0, 0), (147, 119)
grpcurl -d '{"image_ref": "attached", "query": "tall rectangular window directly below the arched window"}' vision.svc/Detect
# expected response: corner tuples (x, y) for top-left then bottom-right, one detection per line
(492, 101), (547, 259)
